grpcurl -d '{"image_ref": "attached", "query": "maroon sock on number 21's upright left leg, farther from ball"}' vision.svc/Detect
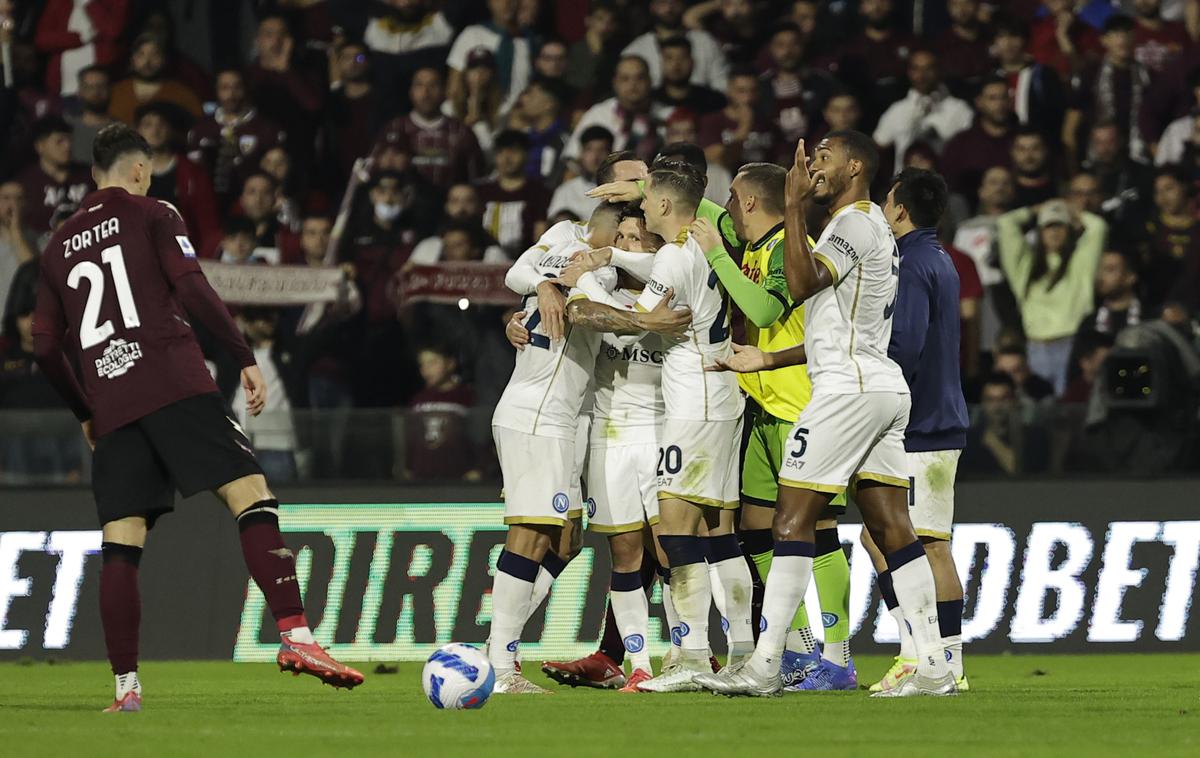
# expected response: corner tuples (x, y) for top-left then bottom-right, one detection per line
(100, 542), (142, 675)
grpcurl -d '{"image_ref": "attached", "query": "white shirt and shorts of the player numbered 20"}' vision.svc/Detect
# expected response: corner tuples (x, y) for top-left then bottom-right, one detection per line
(636, 231), (745, 509)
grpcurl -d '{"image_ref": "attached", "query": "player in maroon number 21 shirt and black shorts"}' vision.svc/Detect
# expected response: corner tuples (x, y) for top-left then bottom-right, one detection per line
(34, 124), (362, 711)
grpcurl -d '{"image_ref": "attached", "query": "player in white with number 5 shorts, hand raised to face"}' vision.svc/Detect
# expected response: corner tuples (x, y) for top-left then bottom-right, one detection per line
(696, 131), (958, 697)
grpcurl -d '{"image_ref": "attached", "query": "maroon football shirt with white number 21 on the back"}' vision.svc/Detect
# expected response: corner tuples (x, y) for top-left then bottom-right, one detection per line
(34, 187), (225, 435)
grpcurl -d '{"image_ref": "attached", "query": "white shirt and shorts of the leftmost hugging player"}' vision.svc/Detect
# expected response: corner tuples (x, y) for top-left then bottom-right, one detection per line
(492, 240), (600, 524)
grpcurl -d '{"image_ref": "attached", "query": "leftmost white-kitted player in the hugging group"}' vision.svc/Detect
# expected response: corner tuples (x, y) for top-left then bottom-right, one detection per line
(488, 200), (689, 693)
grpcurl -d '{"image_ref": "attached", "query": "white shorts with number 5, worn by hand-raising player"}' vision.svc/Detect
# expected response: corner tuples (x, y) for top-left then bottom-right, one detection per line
(779, 392), (911, 495)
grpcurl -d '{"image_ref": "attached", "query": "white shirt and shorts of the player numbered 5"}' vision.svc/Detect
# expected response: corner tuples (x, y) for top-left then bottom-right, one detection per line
(779, 200), (910, 494)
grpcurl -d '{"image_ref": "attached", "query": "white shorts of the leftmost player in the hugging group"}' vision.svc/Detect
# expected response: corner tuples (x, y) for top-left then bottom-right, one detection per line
(492, 427), (582, 525)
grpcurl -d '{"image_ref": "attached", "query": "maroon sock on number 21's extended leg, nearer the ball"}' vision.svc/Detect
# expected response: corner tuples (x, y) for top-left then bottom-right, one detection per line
(238, 500), (308, 632)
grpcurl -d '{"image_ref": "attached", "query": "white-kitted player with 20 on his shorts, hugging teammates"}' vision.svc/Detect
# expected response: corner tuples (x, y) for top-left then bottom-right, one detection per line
(554, 163), (752, 692)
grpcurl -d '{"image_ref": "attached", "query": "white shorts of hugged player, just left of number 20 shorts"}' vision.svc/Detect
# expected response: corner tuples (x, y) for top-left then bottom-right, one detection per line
(588, 443), (659, 534)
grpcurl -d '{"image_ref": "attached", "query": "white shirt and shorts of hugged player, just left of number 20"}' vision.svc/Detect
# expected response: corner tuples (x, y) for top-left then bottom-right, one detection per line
(571, 284), (664, 534)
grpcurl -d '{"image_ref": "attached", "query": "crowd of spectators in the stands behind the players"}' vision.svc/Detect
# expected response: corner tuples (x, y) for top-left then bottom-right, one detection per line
(0, 0), (1200, 479)
